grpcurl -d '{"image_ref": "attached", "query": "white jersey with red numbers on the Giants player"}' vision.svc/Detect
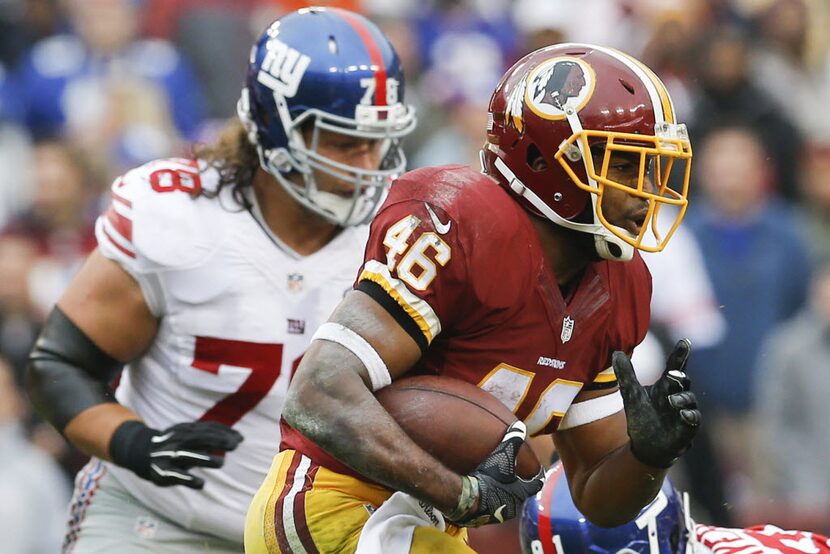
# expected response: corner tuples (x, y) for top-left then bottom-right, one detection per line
(96, 160), (368, 543)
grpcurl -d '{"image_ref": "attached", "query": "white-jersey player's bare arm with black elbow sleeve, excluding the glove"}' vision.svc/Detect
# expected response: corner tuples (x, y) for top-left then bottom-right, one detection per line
(27, 250), (158, 459)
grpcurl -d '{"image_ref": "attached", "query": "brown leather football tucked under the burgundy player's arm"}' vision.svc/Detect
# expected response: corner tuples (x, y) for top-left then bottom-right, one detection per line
(377, 375), (541, 478)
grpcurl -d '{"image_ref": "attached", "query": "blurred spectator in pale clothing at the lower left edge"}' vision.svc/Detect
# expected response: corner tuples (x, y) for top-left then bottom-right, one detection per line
(0, 357), (69, 554)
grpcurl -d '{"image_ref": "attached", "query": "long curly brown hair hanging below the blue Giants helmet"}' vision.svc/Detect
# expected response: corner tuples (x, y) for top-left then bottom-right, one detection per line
(193, 118), (259, 210)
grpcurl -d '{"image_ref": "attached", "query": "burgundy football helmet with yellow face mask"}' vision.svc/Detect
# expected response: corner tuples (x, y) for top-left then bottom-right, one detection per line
(482, 44), (692, 261)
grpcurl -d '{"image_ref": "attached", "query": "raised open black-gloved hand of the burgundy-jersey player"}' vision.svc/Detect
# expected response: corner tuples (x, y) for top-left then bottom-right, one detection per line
(611, 339), (701, 468)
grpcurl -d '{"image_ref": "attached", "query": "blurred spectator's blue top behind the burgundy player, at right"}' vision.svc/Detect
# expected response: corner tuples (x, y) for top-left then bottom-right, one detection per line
(686, 203), (812, 413)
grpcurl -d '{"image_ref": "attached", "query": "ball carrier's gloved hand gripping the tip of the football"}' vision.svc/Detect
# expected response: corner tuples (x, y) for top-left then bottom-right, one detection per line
(447, 421), (545, 527)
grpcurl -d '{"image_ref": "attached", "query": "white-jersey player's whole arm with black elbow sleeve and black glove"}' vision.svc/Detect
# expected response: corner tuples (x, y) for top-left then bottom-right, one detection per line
(26, 250), (241, 488)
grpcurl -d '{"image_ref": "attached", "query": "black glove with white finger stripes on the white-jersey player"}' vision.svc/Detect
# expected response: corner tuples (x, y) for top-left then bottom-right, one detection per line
(109, 421), (242, 489)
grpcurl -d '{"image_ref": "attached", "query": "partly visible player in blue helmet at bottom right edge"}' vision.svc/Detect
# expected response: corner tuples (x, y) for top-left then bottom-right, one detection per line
(520, 462), (830, 554)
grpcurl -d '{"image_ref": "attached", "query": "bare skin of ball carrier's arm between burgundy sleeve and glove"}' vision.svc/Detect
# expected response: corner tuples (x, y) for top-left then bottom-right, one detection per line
(283, 291), (462, 513)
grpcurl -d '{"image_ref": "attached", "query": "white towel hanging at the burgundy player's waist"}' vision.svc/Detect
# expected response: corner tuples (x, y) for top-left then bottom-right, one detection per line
(355, 492), (447, 554)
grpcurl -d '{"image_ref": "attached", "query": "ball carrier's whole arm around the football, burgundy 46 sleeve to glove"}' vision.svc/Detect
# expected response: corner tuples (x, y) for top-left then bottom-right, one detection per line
(283, 201), (542, 525)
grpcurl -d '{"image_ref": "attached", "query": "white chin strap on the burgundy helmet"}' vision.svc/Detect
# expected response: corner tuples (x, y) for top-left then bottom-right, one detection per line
(487, 150), (634, 262)
